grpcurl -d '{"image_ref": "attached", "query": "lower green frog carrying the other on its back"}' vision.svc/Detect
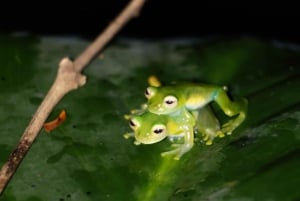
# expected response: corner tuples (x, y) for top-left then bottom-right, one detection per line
(124, 107), (224, 160)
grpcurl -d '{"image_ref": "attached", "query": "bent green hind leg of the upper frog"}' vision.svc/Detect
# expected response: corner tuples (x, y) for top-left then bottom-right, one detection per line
(214, 88), (248, 135)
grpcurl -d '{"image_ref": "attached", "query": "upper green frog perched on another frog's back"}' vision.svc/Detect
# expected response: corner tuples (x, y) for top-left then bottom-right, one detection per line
(145, 80), (248, 135)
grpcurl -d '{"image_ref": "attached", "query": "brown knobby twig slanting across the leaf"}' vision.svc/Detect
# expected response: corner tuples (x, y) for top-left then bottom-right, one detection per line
(0, 0), (145, 195)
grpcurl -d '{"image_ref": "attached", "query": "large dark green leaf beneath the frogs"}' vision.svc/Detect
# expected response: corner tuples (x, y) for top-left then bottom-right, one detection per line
(0, 35), (300, 201)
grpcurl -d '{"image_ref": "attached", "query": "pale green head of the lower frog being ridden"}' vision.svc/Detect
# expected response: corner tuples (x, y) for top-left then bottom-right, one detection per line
(129, 112), (168, 144)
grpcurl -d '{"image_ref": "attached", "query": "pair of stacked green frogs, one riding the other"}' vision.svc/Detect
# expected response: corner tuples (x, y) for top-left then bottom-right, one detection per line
(124, 77), (248, 160)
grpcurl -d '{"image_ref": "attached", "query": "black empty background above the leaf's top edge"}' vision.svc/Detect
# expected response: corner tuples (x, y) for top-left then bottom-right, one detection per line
(0, 0), (300, 43)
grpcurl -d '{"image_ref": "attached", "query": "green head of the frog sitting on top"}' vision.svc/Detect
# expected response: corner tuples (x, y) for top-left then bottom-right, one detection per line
(145, 86), (185, 114)
